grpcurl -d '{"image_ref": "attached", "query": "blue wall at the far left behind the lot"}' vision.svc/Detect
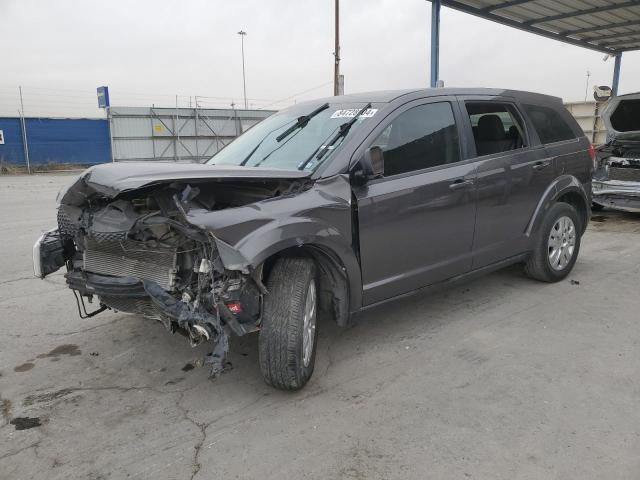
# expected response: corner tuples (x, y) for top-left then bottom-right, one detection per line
(0, 118), (111, 166)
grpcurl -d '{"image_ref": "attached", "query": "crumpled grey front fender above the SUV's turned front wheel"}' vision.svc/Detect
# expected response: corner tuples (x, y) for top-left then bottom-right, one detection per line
(187, 175), (362, 311)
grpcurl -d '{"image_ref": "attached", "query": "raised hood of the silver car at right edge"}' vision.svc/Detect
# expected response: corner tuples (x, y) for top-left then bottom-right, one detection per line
(600, 93), (640, 142)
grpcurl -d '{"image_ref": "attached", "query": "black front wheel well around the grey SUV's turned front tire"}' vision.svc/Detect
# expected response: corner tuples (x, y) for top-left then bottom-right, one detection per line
(263, 248), (349, 326)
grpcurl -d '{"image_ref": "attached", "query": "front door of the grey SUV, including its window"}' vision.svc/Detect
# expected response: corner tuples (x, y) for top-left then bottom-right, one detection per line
(354, 101), (475, 305)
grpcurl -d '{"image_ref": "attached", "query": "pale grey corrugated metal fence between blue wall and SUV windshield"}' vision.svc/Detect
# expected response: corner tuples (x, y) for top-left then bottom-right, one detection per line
(110, 107), (274, 162)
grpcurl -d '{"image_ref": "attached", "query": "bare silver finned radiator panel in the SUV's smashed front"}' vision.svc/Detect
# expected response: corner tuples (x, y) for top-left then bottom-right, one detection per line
(84, 237), (177, 290)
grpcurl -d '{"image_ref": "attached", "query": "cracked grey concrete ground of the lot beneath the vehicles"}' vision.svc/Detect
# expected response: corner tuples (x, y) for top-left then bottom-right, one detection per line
(0, 174), (640, 480)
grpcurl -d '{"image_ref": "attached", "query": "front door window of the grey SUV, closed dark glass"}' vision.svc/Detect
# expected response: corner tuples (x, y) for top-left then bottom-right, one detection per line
(371, 102), (460, 177)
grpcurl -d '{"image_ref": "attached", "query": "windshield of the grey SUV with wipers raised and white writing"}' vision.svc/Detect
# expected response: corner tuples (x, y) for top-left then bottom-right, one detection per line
(207, 102), (378, 171)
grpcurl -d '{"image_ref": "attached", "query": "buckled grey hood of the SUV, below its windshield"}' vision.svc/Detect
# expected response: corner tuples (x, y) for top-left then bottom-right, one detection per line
(58, 162), (311, 205)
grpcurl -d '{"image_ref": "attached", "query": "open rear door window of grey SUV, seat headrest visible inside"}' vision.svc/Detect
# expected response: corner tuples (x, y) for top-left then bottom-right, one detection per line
(465, 102), (525, 156)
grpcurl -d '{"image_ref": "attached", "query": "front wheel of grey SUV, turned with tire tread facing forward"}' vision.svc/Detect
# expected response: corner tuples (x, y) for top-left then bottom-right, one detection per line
(258, 257), (318, 390)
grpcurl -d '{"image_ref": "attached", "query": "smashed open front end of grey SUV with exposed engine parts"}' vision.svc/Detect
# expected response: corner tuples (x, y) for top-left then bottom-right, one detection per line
(34, 174), (308, 376)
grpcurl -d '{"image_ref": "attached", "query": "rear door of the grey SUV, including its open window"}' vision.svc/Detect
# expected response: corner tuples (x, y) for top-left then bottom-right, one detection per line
(462, 96), (556, 269)
